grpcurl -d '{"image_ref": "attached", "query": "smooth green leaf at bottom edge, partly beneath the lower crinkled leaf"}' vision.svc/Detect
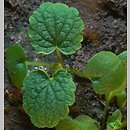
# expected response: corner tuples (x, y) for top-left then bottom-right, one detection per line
(55, 115), (99, 130)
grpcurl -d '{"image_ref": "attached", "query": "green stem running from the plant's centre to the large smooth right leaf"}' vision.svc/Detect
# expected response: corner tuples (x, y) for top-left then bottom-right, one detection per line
(64, 67), (89, 79)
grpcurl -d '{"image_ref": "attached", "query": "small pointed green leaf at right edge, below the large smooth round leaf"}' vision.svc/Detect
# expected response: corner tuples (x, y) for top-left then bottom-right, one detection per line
(116, 91), (127, 111)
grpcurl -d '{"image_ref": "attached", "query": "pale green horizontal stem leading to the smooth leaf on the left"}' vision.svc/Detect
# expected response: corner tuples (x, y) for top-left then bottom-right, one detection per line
(26, 61), (54, 67)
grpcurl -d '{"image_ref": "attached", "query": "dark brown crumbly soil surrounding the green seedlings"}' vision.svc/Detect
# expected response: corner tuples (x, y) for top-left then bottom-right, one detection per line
(4, 0), (127, 130)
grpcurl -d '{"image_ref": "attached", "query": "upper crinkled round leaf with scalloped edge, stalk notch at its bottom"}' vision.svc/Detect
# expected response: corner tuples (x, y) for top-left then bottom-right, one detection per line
(28, 2), (84, 55)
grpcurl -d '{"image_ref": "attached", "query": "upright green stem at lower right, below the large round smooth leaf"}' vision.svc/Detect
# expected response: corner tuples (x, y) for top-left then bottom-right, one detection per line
(100, 96), (110, 130)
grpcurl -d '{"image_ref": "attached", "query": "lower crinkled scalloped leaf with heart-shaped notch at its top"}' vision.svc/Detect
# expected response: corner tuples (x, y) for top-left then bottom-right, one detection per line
(23, 70), (76, 128)
